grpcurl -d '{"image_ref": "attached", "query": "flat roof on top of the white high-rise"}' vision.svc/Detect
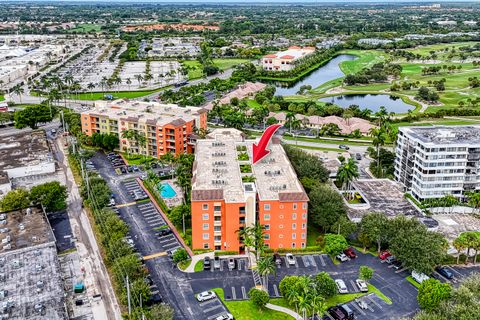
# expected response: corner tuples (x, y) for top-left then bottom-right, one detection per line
(399, 125), (480, 145)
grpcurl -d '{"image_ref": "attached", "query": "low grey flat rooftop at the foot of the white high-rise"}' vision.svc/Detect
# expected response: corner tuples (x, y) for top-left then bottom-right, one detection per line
(348, 179), (420, 220)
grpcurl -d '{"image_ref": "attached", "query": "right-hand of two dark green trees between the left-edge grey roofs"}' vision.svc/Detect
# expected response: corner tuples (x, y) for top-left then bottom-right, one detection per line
(30, 181), (68, 212)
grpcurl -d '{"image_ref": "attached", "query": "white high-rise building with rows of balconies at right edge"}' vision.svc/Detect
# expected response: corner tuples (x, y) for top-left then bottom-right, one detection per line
(395, 125), (480, 200)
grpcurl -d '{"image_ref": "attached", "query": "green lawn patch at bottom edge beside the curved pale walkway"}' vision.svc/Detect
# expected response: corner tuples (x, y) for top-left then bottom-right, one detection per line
(212, 288), (294, 320)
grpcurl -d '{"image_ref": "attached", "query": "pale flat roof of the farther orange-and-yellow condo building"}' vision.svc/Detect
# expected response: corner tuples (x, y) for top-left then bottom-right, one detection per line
(89, 99), (207, 126)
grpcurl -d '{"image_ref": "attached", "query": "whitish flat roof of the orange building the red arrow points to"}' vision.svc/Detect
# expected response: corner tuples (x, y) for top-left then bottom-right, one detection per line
(192, 129), (308, 202)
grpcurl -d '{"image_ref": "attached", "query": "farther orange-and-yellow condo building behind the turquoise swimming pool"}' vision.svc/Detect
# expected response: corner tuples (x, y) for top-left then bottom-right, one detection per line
(81, 100), (207, 157)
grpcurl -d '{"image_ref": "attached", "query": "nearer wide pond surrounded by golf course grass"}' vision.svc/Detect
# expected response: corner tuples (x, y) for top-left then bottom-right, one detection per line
(318, 94), (415, 113)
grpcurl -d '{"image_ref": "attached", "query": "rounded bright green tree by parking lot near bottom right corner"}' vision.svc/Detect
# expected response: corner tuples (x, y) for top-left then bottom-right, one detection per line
(417, 279), (452, 312)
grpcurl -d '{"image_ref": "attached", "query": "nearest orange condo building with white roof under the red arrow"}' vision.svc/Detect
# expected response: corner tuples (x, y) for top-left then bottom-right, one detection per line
(192, 129), (308, 253)
